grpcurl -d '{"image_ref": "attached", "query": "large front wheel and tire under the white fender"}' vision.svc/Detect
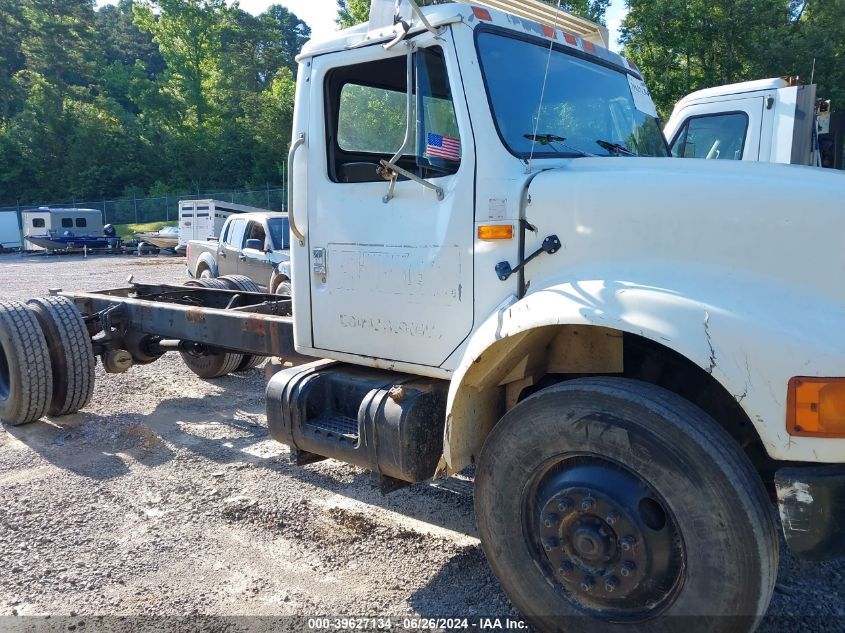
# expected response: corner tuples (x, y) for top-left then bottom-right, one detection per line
(475, 378), (778, 632)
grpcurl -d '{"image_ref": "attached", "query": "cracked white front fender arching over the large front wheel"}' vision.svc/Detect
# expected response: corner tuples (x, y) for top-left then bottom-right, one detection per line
(444, 271), (845, 472)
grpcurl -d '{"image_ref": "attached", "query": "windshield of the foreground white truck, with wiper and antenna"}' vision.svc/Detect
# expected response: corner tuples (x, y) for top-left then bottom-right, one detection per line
(477, 31), (668, 158)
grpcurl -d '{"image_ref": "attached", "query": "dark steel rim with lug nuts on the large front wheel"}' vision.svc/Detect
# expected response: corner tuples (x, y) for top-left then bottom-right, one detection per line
(522, 455), (686, 621)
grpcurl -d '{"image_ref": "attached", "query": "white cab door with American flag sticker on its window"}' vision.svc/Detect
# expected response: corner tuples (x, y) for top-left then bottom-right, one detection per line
(304, 31), (475, 366)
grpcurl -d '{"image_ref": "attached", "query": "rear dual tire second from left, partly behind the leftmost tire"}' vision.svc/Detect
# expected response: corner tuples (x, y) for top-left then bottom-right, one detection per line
(27, 297), (95, 416)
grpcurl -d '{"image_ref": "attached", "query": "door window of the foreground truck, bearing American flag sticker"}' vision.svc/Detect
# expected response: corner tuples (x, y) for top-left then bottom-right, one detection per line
(326, 46), (461, 182)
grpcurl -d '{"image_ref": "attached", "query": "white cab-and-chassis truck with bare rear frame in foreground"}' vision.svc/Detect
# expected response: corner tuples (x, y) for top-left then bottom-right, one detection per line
(0, 0), (845, 633)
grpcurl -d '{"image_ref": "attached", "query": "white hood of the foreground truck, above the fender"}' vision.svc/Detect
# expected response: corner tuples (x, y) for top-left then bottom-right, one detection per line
(526, 157), (845, 307)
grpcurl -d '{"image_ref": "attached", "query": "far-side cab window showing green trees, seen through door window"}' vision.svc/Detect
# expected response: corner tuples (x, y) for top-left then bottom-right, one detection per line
(337, 83), (406, 154)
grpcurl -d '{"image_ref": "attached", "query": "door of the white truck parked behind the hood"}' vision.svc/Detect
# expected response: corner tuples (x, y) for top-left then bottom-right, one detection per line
(669, 96), (765, 161)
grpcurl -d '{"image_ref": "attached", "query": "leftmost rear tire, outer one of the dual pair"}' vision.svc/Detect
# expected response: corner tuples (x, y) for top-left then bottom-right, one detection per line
(0, 301), (53, 426)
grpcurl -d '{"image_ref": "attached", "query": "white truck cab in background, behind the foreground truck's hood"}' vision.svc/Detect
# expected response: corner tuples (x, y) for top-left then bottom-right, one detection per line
(664, 77), (845, 169)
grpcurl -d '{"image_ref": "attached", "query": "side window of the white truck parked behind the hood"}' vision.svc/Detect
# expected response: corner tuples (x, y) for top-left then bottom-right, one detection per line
(672, 112), (748, 160)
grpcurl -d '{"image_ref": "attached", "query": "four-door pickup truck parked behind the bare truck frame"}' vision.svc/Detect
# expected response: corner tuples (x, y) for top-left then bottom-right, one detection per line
(187, 213), (291, 293)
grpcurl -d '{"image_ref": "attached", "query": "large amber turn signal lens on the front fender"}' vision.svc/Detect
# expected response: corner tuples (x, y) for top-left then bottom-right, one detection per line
(786, 376), (845, 437)
